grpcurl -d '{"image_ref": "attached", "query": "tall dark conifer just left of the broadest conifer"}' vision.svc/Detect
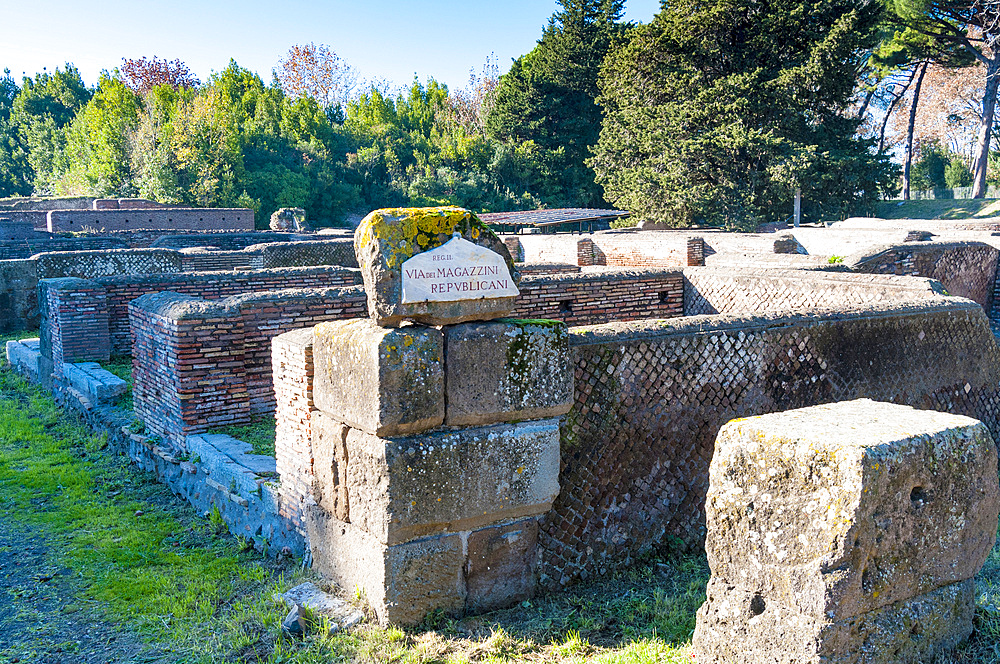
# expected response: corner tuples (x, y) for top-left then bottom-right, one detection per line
(487, 0), (624, 206)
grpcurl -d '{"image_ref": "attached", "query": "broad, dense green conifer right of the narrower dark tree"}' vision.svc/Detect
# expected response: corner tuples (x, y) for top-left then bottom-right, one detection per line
(590, 0), (895, 229)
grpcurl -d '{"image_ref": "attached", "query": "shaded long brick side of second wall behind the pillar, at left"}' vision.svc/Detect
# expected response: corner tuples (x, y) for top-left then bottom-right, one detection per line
(97, 267), (361, 355)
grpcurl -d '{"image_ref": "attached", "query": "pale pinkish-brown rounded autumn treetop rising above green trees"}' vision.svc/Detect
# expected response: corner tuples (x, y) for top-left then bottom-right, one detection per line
(276, 42), (358, 108)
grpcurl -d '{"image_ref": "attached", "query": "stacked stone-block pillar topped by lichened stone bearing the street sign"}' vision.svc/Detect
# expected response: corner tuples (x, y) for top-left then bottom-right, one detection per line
(302, 208), (573, 624)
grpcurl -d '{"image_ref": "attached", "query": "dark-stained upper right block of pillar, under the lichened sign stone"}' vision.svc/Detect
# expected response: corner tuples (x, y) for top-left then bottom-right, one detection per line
(444, 320), (573, 426)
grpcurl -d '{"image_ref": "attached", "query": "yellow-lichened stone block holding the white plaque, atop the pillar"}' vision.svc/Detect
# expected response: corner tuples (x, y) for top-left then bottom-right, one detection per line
(354, 207), (519, 326)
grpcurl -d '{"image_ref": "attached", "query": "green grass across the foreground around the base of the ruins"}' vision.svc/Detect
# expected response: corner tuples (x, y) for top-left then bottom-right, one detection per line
(0, 332), (1000, 664)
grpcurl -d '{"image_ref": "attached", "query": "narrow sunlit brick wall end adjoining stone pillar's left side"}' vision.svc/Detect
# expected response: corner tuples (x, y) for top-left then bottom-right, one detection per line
(271, 328), (316, 535)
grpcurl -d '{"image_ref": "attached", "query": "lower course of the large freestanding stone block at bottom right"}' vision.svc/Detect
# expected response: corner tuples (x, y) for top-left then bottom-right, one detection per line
(694, 579), (975, 664)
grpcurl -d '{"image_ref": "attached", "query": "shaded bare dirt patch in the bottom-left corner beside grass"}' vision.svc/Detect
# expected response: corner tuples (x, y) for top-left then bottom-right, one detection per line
(0, 515), (162, 664)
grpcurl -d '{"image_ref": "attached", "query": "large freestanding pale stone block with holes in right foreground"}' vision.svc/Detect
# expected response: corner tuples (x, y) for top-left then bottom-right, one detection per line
(694, 399), (1000, 662)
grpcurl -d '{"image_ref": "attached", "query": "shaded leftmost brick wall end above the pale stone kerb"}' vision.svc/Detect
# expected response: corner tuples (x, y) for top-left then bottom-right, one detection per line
(39, 277), (111, 366)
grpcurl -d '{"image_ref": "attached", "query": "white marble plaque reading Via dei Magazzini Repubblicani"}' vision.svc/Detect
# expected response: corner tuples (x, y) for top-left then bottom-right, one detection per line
(402, 237), (518, 304)
